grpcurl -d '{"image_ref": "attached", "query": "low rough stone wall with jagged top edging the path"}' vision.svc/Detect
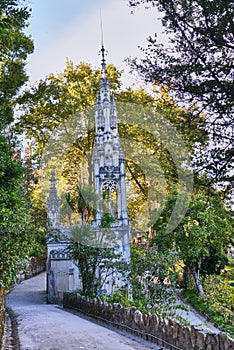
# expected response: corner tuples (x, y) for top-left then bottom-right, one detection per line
(63, 293), (234, 350)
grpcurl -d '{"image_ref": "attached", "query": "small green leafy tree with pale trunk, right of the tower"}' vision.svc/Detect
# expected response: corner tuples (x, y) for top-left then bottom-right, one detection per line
(152, 187), (234, 295)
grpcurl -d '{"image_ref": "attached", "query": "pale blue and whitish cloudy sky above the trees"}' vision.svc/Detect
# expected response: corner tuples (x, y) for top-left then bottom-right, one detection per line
(26, 0), (165, 87)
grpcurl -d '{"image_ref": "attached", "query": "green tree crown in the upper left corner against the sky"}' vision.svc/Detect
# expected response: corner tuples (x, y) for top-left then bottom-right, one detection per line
(0, 0), (33, 129)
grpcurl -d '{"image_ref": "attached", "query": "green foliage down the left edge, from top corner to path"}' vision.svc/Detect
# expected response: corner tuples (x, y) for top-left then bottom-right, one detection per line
(0, 0), (45, 288)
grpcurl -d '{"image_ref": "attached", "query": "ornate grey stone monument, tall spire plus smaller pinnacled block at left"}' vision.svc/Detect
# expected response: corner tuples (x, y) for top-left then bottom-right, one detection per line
(47, 48), (130, 302)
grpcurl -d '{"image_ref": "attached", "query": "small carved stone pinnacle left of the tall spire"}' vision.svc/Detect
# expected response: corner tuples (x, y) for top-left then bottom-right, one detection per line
(47, 170), (60, 229)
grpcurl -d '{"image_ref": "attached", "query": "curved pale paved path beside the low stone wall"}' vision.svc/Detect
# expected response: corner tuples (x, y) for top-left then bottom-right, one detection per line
(7, 273), (163, 350)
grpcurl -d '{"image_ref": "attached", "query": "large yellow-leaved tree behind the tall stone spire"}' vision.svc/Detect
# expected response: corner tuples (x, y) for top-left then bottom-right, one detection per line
(19, 61), (206, 230)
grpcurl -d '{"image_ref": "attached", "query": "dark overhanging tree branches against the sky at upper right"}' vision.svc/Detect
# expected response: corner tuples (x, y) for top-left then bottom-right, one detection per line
(129, 0), (234, 194)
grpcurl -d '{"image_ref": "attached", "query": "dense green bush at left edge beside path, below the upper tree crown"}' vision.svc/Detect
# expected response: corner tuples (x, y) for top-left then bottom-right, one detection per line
(0, 136), (45, 287)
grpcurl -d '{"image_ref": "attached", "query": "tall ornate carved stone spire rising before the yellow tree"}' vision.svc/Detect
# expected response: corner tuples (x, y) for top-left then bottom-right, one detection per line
(93, 45), (130, 255)
